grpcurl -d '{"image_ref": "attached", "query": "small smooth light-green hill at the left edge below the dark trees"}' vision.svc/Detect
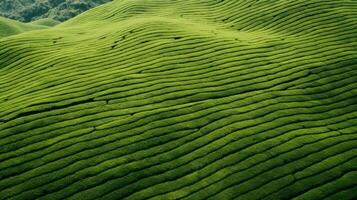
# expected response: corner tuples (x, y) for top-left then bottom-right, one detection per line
(0, 17), (48, 38)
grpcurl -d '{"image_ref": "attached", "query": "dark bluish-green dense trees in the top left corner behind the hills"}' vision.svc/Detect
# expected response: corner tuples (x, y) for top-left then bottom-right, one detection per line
(0, 0), (111, 22)
